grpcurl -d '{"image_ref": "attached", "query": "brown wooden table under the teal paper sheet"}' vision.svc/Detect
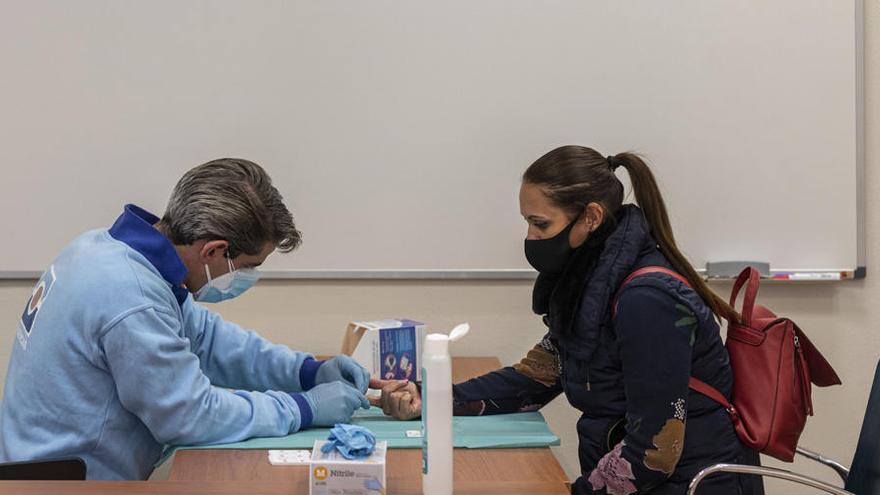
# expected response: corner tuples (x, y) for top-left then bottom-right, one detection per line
(0, 358), (569, 495)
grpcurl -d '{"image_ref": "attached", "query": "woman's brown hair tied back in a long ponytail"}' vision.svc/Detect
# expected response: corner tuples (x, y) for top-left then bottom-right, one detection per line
(523, 146), (739, 321)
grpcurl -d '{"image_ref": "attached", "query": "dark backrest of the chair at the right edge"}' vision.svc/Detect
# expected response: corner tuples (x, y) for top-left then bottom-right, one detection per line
(846, 362), (880, 495)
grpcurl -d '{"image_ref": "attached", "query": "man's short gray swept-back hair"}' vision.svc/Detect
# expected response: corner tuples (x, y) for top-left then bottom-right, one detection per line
(159, 158), (302, 258)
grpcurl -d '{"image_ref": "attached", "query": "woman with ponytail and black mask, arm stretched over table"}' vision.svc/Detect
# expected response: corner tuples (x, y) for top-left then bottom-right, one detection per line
(372, 146), (763, 495)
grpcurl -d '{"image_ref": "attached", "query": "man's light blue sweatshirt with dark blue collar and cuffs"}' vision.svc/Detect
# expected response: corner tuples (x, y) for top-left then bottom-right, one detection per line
(0, 205), (320, 479)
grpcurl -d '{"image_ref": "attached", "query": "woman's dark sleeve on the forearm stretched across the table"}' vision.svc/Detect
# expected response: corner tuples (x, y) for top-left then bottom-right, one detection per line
(452, 336), (562, 416)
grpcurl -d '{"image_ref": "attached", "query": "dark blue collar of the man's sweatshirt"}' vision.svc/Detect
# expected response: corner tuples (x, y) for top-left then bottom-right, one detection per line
(109, 204), (189, 305)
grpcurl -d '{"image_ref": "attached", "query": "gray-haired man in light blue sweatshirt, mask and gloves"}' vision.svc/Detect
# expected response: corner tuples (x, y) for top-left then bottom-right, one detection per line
(0, 158), (370, 479)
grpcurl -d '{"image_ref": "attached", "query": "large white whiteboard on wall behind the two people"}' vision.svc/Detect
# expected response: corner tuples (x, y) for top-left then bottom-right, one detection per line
(0, 0), (863, 276)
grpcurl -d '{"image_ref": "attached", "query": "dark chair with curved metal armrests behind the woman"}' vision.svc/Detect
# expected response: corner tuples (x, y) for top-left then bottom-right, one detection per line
(688, 362), (880, 495)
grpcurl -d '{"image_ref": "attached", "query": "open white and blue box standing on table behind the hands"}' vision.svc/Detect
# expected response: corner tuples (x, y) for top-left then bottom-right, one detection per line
(342, 319), (427, 382)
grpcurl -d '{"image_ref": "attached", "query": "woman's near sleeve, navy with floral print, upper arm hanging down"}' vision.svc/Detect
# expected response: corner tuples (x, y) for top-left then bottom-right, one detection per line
(578, 286), (697, 495)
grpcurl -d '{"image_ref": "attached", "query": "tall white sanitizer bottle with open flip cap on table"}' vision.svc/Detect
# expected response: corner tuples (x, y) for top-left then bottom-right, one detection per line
(422, 323), (470, 495)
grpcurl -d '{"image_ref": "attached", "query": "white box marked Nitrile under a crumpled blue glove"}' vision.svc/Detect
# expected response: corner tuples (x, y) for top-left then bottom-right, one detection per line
(309, 440), (388, 495)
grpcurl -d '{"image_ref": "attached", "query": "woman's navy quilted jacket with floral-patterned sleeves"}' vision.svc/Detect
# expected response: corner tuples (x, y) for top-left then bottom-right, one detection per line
(454, 205), (741, 495)
